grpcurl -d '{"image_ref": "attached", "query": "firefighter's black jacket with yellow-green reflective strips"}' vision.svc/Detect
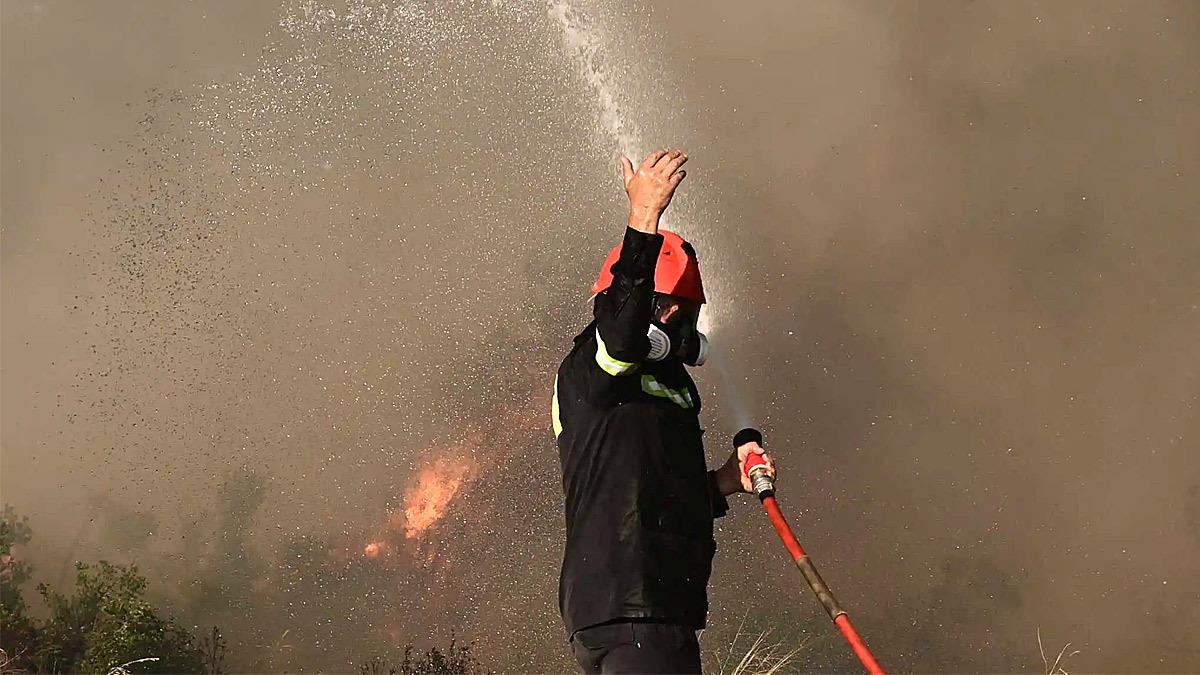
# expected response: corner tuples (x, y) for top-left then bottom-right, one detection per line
(551, 228), (728, 634)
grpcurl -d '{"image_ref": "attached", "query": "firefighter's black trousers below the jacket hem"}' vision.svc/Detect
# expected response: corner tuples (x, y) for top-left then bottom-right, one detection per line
(571, 621), (700, 675)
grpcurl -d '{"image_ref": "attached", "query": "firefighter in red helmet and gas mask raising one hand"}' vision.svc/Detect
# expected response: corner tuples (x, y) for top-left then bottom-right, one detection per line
(551, 150), (774, 673)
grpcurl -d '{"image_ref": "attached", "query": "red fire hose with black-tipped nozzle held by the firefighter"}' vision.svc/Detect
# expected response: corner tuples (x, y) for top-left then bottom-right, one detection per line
(733, 429), (883, 675)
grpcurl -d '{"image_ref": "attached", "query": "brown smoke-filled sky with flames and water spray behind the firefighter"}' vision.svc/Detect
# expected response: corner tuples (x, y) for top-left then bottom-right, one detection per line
(0, 0), (1200, 673)
